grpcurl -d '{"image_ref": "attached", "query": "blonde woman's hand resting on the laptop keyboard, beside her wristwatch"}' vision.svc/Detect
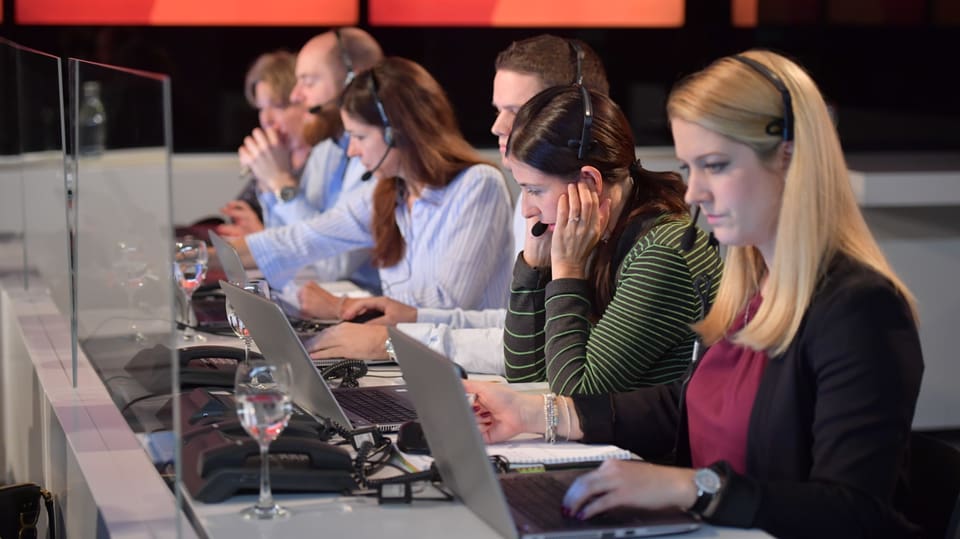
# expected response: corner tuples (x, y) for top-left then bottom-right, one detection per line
(563, 459), (697, 520)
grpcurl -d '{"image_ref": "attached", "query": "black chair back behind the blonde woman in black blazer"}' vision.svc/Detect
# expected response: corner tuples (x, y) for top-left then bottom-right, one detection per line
(907, 432), (960, 539)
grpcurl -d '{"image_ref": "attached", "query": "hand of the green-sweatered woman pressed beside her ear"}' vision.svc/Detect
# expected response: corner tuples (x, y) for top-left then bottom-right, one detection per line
(550, 181), (610, 279)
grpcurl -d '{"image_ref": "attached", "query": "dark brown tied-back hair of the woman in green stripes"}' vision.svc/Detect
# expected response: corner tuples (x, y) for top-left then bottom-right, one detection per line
(507, 85), (688, 318)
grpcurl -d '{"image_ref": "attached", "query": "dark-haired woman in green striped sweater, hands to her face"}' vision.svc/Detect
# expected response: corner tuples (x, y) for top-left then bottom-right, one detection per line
(504, 86), (722, 395)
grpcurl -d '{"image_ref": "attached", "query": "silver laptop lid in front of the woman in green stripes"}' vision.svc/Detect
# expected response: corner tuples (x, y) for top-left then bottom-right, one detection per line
(220, 281), (353, 429)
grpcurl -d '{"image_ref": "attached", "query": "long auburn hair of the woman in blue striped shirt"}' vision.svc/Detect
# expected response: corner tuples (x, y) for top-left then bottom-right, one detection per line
(340, 57), (486, 268)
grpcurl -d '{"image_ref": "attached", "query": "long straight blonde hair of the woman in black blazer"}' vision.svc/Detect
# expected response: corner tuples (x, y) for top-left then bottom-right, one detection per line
(667, 50), (917, 355)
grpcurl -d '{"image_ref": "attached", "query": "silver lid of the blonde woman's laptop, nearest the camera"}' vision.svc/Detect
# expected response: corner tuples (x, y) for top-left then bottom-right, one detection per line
(387, 327), (517, 537)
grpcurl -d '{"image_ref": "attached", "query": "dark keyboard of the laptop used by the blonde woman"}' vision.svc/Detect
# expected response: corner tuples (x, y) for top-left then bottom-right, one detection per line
(500, 473), (616, 530)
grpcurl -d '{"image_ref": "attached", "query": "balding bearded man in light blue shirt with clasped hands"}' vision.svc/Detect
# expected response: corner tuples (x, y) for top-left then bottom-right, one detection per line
(230, 28), (383, 291)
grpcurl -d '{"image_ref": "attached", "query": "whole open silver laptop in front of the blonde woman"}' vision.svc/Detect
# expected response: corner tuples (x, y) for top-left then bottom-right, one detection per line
(388, 328), (700, 538)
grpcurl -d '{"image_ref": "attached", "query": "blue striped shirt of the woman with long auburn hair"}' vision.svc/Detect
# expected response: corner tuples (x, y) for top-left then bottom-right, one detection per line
(247, 165), (513, 309)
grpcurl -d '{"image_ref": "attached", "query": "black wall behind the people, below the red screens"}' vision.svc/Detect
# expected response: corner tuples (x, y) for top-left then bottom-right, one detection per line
(0, 0), (960, 152)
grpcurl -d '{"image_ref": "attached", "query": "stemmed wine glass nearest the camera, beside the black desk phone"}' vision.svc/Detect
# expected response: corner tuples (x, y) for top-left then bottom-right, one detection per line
(235, 359), (293, 520)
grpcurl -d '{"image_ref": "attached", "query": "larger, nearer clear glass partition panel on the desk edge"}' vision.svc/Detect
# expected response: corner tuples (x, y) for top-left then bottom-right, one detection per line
(68, 59), (180, 536)
